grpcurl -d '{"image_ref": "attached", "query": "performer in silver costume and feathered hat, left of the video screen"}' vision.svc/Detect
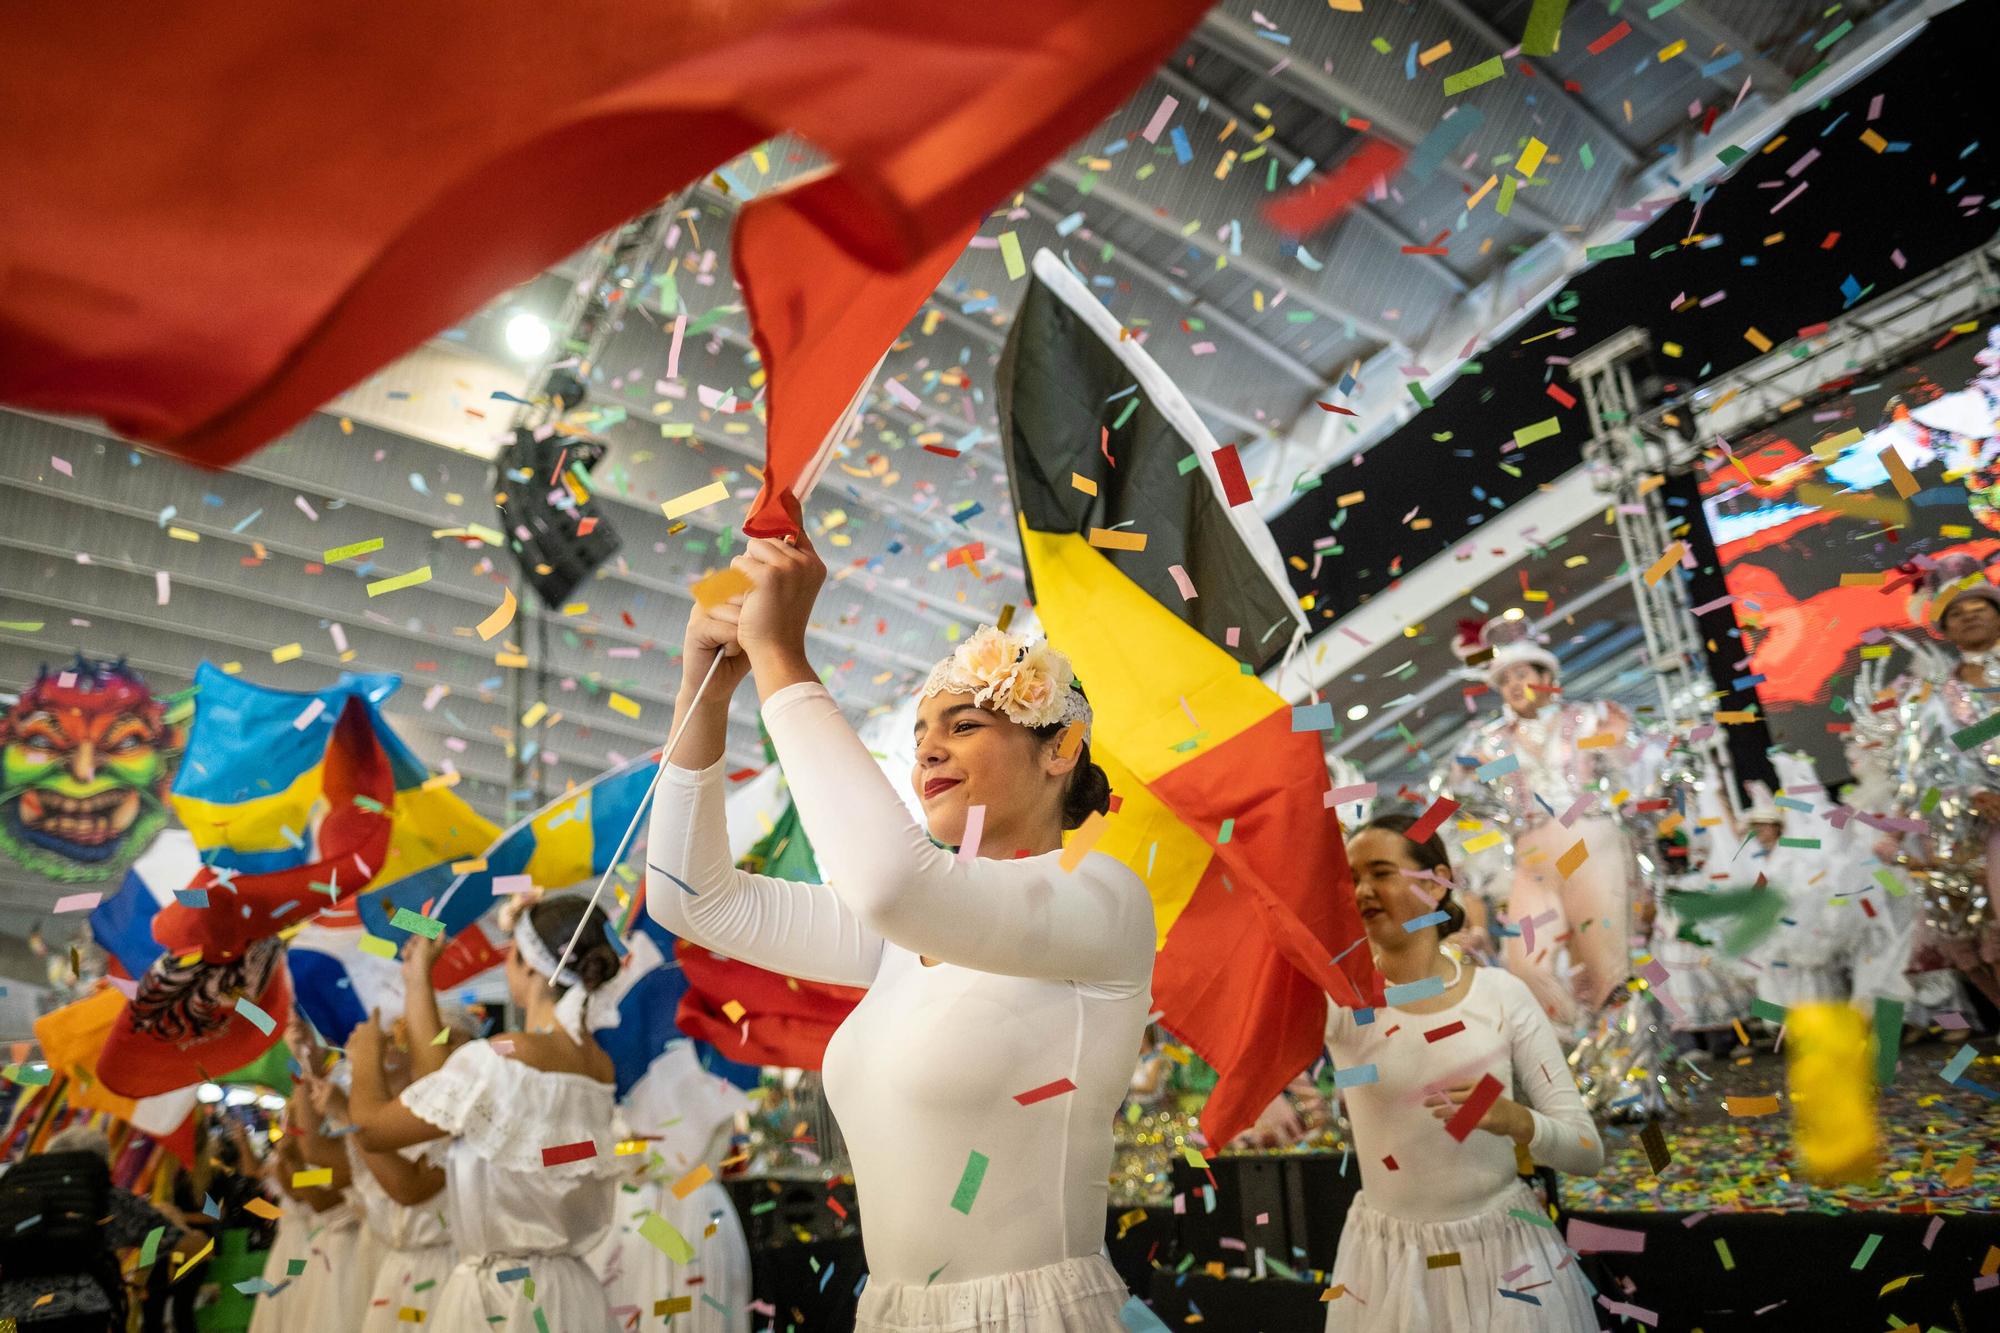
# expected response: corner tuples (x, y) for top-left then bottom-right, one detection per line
(1436, 618), (1650, 1033)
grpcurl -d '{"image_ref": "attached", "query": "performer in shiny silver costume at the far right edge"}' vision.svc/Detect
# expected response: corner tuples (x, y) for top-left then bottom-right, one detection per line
(1856, 554), (2000, 1003)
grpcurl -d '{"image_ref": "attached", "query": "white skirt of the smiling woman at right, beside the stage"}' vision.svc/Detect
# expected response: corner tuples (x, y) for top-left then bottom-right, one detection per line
(1326, 1185), (1598, 1333)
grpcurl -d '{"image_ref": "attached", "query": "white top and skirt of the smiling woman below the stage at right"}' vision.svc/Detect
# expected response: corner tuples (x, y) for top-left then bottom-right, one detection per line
(1326, 967), (1604, 1333)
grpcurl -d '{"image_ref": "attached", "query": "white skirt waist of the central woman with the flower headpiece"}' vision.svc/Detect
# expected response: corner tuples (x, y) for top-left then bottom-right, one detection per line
(854, 1255), (1128, 1333)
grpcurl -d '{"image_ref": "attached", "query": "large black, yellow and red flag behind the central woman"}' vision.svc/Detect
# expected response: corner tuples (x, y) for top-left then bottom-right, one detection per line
(998, 250), (1382, 1145)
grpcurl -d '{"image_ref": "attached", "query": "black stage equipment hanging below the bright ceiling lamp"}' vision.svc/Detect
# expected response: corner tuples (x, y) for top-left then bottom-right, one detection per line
(494, 426), (622, 610)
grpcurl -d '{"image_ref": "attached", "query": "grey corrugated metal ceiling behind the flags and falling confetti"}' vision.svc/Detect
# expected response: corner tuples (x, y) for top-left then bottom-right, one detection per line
(0, 0), (1936, 932)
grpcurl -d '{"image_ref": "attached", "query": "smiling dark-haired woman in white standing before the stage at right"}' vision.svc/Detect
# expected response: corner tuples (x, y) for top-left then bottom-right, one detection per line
(1326, 815), (1604, 1333)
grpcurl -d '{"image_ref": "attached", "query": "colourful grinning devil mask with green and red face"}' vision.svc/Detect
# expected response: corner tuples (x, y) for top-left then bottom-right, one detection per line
(0, 658), (182, 883)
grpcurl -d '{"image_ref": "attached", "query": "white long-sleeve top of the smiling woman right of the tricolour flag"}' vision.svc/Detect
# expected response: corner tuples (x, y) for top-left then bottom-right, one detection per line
(1326, 967), (1604, 1223)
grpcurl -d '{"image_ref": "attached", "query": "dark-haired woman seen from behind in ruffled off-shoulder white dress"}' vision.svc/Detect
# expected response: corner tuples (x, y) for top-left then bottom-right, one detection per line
(348, 897), (628, 1333)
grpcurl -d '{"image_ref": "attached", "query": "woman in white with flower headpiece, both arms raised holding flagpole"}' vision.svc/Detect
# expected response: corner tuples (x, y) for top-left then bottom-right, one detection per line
(646, 540), (1154, 1333)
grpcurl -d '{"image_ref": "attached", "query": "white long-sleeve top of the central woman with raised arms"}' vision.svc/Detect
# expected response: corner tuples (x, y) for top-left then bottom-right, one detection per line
(646, 683), (1154, 1283)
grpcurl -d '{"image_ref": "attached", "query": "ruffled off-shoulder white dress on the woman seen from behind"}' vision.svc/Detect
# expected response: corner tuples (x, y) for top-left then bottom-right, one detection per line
(398, 1041), (630, 1333)
